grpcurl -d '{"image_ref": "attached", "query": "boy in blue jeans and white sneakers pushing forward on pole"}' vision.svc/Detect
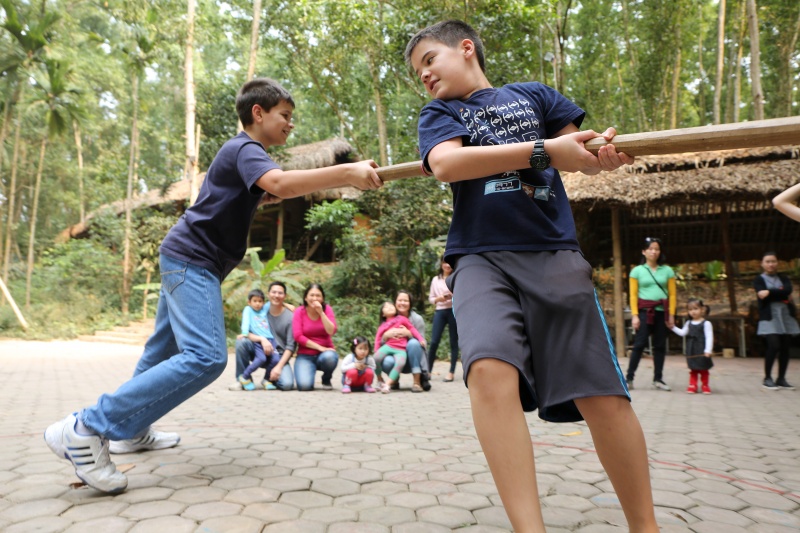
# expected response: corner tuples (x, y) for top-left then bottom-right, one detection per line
(44, 78), (381, 493)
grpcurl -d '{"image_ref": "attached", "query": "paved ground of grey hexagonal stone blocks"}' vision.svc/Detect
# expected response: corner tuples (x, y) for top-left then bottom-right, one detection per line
(0, 341), (800, 533)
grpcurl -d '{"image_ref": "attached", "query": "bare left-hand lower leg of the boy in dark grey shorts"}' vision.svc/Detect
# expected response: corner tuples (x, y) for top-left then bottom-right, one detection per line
(468, 359), (545, 533)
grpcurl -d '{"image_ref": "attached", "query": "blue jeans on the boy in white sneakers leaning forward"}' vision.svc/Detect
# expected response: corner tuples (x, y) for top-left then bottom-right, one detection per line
(80, 254), (228, 440)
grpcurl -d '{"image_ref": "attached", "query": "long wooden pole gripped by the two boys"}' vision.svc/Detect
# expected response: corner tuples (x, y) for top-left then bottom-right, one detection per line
(377, 116), (800, 181)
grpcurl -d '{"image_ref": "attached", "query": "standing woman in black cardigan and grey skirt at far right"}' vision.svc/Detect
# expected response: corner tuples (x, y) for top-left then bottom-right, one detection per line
(753, 252), (800, 390)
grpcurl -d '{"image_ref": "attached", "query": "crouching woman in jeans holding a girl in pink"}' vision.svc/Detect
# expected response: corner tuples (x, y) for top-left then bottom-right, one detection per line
(375, 290), (431, 392)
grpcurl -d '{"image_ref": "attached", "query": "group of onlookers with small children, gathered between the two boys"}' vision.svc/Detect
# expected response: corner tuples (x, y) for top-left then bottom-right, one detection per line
(230, 259), (458, 394)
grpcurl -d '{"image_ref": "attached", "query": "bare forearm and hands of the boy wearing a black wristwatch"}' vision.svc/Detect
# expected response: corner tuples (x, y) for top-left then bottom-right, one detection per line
(428, 124), (633, 183)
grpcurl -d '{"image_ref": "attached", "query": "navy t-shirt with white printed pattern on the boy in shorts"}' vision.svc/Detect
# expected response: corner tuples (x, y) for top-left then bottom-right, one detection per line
(419, 83), (586, 257)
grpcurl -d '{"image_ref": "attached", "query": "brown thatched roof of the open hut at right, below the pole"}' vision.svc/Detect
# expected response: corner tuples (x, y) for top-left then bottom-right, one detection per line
(562, 146), (800, 209)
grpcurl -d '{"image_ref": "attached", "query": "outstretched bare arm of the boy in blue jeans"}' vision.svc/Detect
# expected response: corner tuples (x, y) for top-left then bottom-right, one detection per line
(256, 160), (383, 198)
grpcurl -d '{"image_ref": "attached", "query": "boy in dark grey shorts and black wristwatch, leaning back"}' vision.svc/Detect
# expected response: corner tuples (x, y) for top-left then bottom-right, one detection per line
(405, 21), (658, 533)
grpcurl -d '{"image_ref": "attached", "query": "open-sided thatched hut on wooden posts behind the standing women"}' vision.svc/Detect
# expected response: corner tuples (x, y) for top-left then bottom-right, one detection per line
(562, 146), (800, 353)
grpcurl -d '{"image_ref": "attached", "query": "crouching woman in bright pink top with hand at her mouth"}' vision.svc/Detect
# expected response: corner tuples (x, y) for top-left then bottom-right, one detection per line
(292, 283), (339, 391)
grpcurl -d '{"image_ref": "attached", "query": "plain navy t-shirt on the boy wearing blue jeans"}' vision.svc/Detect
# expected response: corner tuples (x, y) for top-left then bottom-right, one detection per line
(161, 132), (280, 280)
